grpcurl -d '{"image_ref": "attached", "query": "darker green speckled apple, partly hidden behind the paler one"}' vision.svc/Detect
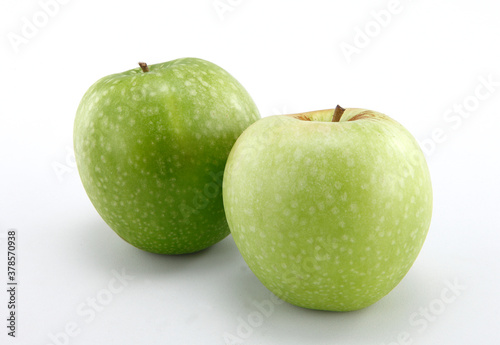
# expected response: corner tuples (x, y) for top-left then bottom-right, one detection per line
(74, 58), (260, 254)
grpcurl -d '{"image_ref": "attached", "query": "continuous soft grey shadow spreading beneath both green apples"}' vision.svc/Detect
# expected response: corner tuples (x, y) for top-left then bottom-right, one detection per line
(71, 219), (427, 344)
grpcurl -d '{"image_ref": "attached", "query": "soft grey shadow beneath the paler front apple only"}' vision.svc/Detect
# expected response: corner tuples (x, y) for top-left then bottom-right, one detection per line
(223, 262), (430, 344)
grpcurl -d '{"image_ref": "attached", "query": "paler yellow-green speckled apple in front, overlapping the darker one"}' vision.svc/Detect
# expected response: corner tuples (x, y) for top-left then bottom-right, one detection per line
(223, 108), (432, 311)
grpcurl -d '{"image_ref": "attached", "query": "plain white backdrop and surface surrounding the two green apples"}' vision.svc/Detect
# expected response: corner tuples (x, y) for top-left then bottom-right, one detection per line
(0, 0), (500, 345)
